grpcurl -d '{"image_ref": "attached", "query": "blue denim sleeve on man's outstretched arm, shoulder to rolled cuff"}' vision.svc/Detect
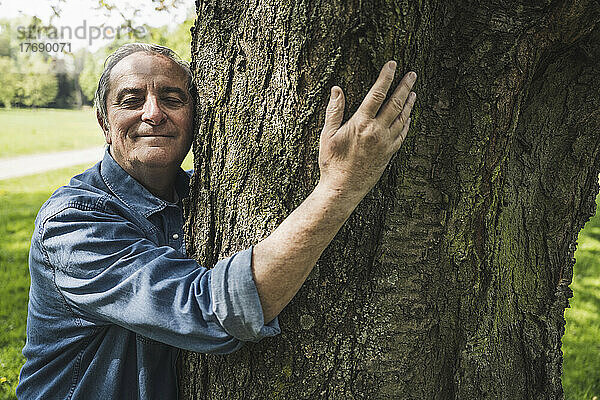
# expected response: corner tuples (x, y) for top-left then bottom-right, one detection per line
(41, 207), (280, 354)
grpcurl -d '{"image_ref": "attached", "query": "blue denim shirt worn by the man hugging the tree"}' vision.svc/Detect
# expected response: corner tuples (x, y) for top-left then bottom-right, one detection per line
(17, 151), (280, 399)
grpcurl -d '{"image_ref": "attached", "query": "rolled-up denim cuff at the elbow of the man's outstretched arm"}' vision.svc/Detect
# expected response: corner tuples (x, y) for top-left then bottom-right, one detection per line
(210, 247), (280, 342)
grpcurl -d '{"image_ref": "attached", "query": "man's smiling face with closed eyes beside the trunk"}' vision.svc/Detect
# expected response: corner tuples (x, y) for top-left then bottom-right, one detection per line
(105, 52), (192, 170)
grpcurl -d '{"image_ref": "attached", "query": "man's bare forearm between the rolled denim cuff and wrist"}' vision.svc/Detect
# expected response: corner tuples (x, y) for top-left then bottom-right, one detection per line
(252, 184), (362, 322)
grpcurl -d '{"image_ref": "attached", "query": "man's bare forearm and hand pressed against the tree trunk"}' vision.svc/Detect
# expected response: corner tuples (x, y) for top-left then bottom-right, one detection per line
(252, 61), (417, 322)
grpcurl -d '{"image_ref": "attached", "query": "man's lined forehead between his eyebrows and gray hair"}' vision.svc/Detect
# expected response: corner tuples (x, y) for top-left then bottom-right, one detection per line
(108, 52), (188, 96)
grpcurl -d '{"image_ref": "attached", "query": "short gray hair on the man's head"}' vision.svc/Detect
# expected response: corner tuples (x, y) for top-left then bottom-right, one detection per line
(94, 43), (194, 127)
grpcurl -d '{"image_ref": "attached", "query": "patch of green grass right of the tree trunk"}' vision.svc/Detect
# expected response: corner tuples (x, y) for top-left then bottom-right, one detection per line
(563, 195), (600, 400)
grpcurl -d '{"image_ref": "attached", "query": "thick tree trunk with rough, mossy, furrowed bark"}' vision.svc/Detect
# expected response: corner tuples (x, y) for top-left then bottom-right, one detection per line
(180, 0), (600, 400)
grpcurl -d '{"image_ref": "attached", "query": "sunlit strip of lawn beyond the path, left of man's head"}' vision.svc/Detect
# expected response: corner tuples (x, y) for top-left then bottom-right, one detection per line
(0, 108), (104, 158)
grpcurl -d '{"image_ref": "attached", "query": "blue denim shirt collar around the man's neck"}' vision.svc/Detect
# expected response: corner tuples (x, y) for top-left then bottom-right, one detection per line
(100, 147), (190, 218)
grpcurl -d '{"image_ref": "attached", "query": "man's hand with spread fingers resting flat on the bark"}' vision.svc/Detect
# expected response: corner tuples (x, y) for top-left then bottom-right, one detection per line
(319, 61), (417, 199)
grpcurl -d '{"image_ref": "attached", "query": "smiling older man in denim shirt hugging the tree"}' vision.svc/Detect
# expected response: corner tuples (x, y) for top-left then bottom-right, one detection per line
(17, 44), (416, 399)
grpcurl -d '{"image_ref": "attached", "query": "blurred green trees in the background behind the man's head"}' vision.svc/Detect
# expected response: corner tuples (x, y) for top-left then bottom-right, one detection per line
(0, 12), (194, 108)
